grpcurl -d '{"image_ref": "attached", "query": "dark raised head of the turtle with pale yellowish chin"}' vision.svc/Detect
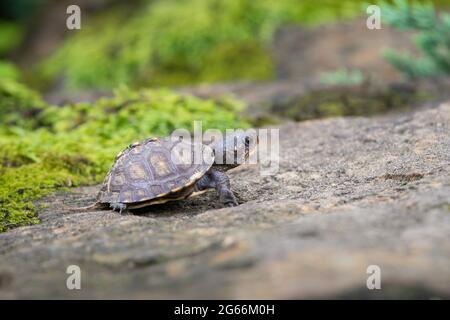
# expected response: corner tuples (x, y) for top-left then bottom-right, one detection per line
(211, 130), (259, 170)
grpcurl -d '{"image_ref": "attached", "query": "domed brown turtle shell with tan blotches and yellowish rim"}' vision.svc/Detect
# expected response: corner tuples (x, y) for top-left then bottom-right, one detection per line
(97, 137), (214, 208)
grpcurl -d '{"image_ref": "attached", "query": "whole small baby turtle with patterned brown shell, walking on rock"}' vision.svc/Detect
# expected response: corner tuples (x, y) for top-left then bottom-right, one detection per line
(72, 131), (258, 213)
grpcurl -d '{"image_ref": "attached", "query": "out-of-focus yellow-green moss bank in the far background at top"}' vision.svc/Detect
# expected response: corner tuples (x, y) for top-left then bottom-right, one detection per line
(36, 0), (372, 89)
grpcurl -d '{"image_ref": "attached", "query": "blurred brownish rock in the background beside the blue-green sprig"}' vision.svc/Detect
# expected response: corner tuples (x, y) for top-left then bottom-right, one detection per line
(273, 19), (417, 82)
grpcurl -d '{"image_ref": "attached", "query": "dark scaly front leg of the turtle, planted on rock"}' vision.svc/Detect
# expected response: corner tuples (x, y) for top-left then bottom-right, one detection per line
(196, 170), (239, 207)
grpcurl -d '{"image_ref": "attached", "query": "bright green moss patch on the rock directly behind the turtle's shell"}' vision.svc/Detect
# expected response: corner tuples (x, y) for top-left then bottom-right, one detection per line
(0, 82), (247, 231)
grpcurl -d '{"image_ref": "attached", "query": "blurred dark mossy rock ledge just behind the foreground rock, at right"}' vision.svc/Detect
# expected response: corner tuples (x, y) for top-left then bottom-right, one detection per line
(178, 77), (450, 126)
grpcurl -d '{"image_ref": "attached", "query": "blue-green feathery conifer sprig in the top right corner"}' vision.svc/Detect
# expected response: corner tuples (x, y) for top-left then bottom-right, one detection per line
(382, 0), (450, 79)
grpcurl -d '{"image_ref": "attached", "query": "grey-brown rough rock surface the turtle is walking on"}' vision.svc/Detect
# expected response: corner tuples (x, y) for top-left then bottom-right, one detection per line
(0, 103), (450, 299)
